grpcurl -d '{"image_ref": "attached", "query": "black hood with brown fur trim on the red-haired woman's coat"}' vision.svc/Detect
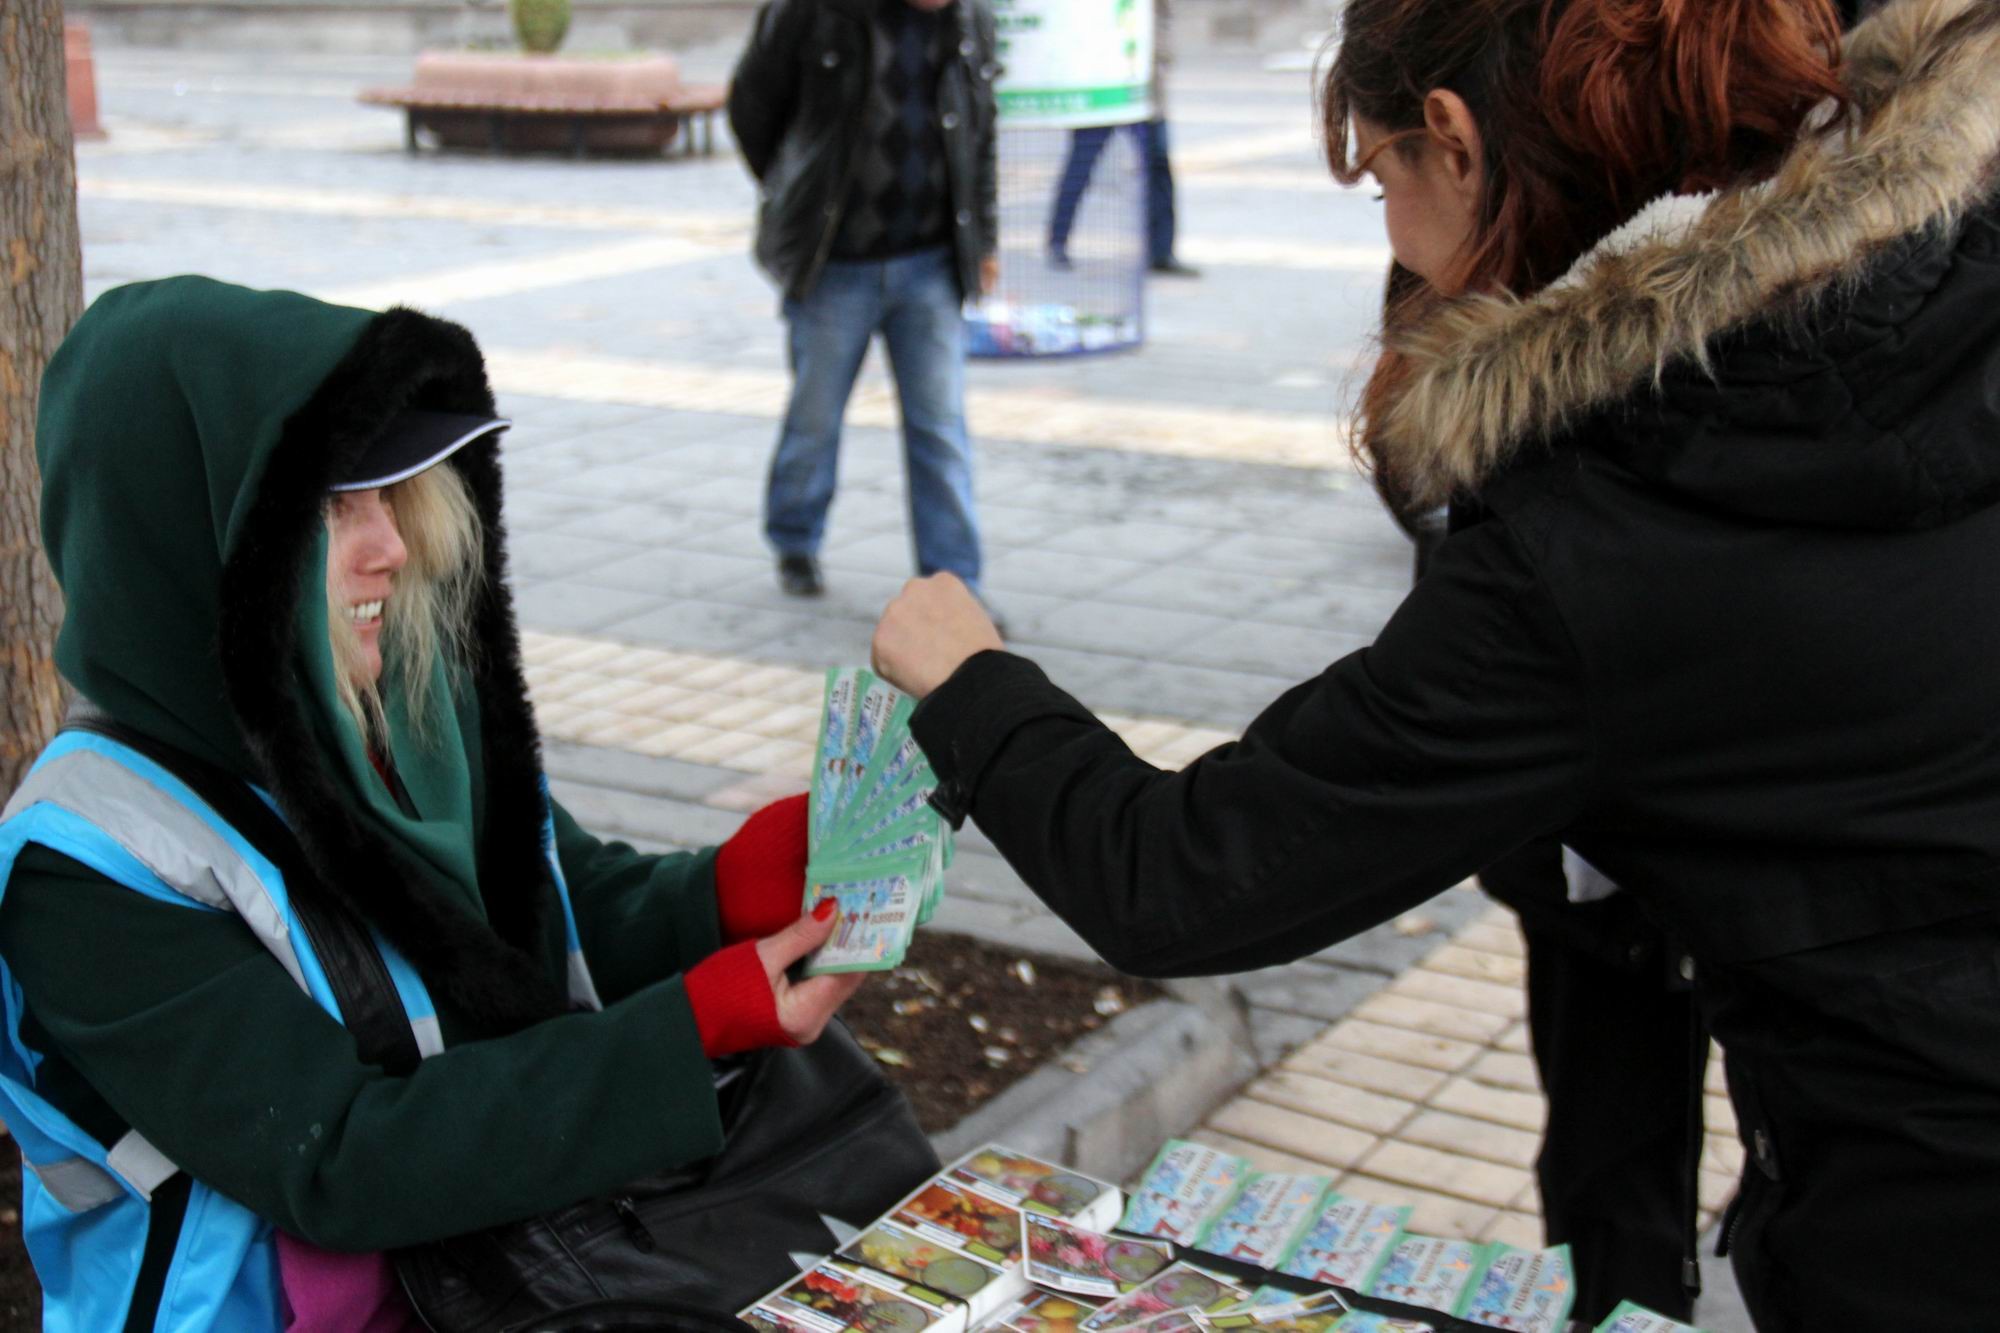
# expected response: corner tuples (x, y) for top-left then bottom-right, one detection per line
(1376, 0), (2000, 526)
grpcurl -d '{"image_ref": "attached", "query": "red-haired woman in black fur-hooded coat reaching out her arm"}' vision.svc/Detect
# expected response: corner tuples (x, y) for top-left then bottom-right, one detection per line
(874, 0), (2000, 1333)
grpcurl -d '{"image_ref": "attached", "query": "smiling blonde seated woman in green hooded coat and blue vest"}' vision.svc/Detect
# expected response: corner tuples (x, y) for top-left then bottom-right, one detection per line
(0, 278), (884, 1331)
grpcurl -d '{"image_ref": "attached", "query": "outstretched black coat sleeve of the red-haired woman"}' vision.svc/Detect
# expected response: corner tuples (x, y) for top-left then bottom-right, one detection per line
(912, 520), (1592, 977)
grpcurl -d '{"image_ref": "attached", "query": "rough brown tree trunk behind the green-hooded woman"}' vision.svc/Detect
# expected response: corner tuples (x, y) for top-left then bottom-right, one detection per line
(0, 0), (84, 799)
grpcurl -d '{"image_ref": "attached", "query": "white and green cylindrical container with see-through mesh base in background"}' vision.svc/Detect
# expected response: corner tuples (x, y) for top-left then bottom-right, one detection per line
(968, 0), (1154, 356)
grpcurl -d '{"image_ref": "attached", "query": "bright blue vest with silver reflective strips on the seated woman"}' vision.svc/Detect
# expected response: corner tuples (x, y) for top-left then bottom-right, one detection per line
(0, 733), (600, 1333)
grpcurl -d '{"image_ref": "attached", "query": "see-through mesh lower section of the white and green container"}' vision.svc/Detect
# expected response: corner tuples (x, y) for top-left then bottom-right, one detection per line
(966, 126), (1146, 356)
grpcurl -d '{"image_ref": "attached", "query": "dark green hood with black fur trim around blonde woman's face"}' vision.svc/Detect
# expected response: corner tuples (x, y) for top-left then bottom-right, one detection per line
(36, 278), (562, 1029)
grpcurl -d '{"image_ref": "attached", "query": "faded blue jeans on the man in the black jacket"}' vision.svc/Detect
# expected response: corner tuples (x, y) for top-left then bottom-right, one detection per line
(764, 248), (980, 588)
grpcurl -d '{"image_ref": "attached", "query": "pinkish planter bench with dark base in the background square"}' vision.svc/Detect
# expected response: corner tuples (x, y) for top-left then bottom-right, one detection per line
(360, 52), (728, 156)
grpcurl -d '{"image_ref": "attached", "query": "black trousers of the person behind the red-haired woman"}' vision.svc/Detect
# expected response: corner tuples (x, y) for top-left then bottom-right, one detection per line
(1480, 843), (1706, 1327)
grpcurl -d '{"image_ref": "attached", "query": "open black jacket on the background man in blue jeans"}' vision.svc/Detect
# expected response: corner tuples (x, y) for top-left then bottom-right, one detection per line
(730, 0), (1000, 300)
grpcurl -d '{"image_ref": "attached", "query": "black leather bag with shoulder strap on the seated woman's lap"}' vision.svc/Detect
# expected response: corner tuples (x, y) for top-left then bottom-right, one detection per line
(68, 711), (938, 1333)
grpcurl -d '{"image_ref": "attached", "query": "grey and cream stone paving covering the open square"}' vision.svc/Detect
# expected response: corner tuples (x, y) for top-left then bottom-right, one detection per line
(78, 44), (1730, 1329)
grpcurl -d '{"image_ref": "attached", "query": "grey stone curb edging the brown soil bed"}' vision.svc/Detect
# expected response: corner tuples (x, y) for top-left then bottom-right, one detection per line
(930, 984), (1256, 1183)
